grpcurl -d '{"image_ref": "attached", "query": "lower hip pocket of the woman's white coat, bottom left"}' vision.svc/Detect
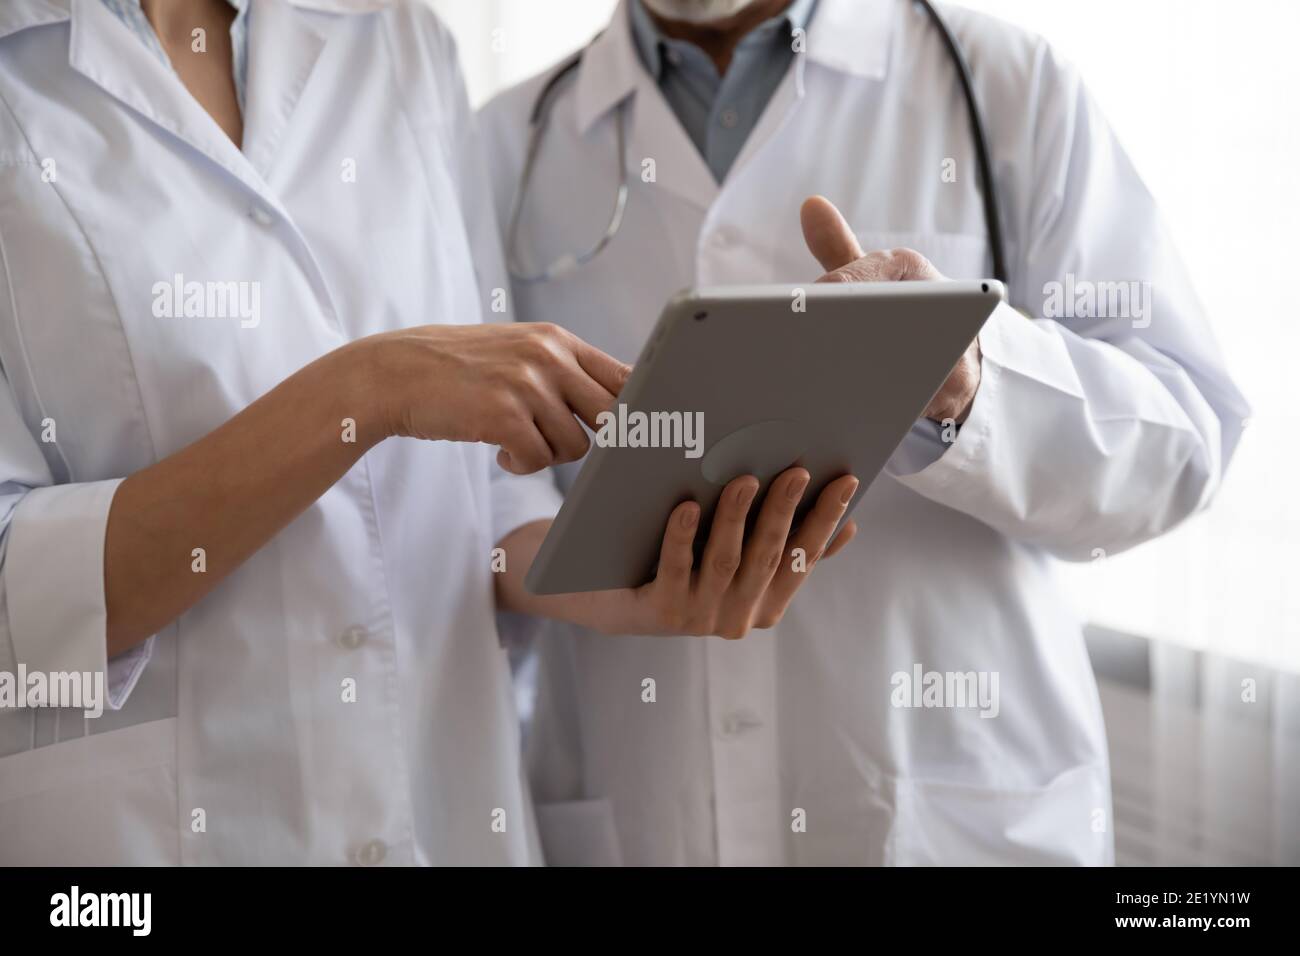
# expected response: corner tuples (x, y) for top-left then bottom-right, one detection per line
(0, 718), (180, 866)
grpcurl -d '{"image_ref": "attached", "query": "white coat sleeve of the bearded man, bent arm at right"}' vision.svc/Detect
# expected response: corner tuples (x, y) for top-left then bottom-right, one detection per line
(889, 39), (1249, 561)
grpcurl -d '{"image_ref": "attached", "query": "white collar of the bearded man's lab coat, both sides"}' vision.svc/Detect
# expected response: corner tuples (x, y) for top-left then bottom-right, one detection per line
(575, 0), (902, 135)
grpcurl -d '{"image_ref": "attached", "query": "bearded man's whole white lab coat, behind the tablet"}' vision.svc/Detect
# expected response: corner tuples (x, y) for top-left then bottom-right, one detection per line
(484, 0), (1247, 864)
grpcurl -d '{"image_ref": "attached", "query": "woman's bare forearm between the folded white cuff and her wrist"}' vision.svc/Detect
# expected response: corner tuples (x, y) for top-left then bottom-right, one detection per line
(104, 343), (385, 657)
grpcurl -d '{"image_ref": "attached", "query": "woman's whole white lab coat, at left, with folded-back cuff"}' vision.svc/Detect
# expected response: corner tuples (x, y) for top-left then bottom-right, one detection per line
(0, 0), (558, 864)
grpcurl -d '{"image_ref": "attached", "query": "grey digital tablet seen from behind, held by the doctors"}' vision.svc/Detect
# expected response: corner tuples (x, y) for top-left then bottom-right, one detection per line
(525, 280), (1005, 594)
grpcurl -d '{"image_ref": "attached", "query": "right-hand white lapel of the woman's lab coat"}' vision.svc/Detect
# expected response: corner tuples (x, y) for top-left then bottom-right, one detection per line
(243, 0), (333, 178)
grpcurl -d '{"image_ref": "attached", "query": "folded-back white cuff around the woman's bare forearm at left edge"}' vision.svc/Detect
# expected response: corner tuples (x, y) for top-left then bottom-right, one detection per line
(4, 479), (153, 710)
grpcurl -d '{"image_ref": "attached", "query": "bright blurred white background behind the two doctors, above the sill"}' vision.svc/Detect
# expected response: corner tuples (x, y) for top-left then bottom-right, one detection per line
(433, 0), (1300, 672)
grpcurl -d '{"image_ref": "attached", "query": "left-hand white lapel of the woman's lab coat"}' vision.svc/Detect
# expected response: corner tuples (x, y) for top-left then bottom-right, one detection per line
(68, 0), (260, 191)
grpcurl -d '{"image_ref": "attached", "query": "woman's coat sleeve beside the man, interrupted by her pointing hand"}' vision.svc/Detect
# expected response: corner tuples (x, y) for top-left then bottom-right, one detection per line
(426, 14), (562, 546)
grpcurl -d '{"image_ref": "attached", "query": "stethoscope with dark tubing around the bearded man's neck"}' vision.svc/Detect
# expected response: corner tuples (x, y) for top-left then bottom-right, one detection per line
(506, 0), (1008, 282)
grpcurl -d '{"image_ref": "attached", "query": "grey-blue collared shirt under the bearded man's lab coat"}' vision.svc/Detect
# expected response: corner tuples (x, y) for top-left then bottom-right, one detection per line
(628, 0), (816, 182)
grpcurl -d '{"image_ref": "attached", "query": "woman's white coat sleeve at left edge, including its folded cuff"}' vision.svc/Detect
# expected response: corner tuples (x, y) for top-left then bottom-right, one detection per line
(0, 366), (153, 710)
